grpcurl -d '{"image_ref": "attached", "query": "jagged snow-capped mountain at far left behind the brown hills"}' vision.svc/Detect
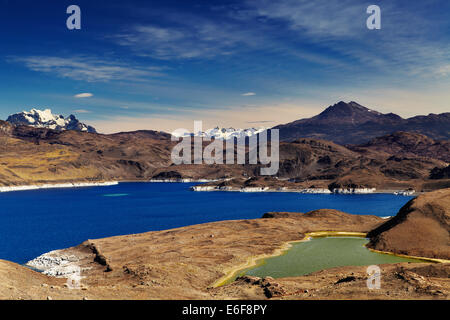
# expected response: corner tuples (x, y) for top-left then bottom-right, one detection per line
(6, 109), (97, 133)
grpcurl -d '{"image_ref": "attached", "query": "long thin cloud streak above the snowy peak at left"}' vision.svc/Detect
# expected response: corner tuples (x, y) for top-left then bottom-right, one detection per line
(10, 56), (162, 82)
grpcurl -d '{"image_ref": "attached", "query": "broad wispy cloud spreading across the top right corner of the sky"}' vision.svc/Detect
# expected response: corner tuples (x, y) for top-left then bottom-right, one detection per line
(246, 0), (450, 76)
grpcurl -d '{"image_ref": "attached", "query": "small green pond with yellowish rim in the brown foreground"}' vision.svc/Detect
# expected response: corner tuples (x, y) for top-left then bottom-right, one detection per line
(240, 237), (421, 278)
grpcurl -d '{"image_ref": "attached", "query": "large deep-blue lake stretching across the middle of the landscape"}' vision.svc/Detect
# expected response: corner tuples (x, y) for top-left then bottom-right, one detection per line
(0, 183), (411, 263)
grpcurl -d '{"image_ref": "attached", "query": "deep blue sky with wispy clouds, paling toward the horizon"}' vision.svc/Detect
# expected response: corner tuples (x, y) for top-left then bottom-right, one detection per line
(0, 0), (450, 132)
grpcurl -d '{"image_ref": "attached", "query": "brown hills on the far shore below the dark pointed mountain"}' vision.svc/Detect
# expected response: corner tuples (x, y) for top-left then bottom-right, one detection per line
(197, 139), (449, 190)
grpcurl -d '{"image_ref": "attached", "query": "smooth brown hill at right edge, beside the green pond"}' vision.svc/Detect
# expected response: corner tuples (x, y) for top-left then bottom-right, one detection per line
(368, 189), (450, 259)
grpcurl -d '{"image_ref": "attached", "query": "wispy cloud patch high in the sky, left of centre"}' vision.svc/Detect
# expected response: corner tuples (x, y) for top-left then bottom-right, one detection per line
(110, 14), (263, 60)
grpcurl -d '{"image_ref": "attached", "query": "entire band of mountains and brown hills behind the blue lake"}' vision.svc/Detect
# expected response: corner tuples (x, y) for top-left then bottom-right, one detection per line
(0, 102), (450, 190)
